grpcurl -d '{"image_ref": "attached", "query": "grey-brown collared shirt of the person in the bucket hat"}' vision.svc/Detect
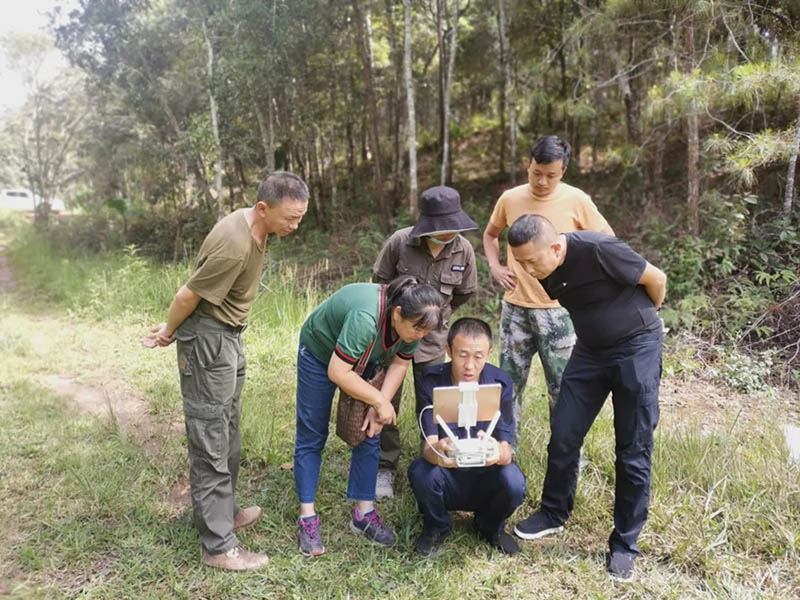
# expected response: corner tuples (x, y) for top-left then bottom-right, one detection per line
(372, 227), (478, 362)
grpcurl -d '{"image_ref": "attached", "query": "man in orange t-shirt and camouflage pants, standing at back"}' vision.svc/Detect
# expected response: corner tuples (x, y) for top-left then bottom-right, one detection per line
(483, 135), (614, 441)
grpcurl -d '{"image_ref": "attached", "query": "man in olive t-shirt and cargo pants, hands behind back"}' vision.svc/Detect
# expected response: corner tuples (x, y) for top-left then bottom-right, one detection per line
(142, 171), (308, 571)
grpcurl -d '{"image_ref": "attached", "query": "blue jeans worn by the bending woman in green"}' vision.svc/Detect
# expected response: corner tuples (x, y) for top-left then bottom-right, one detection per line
(294, 344), (380, 503)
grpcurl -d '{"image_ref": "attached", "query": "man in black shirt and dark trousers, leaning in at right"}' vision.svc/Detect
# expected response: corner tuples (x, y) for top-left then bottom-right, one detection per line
(508, 215), (667, 581)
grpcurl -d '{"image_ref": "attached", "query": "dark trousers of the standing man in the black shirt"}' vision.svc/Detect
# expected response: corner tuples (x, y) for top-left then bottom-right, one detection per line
(542, 328), (662, 554)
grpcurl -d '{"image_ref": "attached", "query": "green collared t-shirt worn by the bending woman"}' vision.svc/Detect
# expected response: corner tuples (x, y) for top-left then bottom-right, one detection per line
(300, 283), (419, 365)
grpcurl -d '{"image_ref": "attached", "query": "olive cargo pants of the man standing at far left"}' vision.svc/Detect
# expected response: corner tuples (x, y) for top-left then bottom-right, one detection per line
(176, 314), (245, 554)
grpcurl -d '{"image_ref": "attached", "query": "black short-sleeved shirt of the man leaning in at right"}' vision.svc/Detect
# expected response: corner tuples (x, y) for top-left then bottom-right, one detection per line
(541, 231), (660, 348)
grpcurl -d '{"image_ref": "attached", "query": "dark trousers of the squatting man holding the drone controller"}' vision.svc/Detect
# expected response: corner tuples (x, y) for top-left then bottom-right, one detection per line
(408, 458), (525, 535)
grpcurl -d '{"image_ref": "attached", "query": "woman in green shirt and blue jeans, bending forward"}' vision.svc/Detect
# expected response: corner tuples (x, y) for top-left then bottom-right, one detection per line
(294, 276), (442, 556)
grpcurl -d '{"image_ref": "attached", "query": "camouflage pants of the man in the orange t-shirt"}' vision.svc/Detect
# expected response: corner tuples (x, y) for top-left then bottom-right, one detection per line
(500, 301), (575, 438)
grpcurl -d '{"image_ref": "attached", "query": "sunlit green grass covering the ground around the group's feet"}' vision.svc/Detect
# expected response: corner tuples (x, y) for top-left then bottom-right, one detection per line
(0, 229), (800, 598)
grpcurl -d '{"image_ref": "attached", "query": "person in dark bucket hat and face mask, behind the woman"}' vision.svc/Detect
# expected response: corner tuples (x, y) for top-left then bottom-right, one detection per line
(372, 186), (478, 500)
